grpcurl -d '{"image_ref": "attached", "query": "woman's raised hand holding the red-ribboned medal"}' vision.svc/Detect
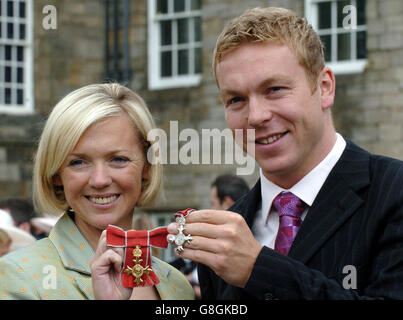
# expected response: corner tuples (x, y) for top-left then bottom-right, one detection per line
(91, 231), (132, 300)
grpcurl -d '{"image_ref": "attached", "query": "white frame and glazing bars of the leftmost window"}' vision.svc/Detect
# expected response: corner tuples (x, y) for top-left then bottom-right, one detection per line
(0, 0), (34, 115)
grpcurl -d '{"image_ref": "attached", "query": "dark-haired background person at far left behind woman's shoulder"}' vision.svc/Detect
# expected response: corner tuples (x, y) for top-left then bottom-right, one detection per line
(0, 198), (41, 239)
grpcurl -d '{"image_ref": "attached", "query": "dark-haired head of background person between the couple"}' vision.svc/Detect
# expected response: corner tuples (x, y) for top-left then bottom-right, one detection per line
(210, 174), (249, 210)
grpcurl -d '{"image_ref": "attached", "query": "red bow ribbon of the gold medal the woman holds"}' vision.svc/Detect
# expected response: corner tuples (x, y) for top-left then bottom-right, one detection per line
(106, 225), (168, 288)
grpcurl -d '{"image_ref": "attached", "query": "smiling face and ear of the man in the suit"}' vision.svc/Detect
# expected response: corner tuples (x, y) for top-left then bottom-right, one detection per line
(216, 43), (336, 188)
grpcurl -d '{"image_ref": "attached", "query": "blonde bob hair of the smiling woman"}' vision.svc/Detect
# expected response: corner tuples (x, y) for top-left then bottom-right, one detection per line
(33, 83), (162, 214)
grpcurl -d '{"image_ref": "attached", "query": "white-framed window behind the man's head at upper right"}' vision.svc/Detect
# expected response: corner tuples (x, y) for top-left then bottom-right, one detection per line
(305, 0), (367, 74)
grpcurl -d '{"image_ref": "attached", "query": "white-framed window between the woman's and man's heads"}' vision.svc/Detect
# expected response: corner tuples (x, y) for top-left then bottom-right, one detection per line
(148, 0), (202, 89)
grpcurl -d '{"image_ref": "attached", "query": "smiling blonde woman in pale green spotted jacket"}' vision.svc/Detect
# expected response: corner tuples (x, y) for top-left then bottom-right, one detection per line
(0, 84), (193, 299)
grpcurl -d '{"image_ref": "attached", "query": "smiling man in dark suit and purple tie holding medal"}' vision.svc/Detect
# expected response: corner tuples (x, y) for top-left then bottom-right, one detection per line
(168, 8), (403, 299)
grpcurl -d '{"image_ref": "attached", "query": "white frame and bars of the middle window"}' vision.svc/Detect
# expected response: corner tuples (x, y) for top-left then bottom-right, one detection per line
(147, 0), (203, 90)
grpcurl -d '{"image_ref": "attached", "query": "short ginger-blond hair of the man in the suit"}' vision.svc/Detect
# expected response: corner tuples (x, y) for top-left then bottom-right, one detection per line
(213, 7), (325, 89)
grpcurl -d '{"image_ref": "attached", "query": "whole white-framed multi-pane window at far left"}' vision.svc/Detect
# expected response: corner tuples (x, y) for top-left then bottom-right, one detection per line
(0, 0), (33, 114)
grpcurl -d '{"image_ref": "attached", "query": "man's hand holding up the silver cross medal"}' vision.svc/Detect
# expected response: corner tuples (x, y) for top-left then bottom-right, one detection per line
(168, 210), (262, 288)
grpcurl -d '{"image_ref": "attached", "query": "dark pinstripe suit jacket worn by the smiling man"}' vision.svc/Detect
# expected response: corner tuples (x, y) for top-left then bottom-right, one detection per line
(199, 141), (403, 300)
